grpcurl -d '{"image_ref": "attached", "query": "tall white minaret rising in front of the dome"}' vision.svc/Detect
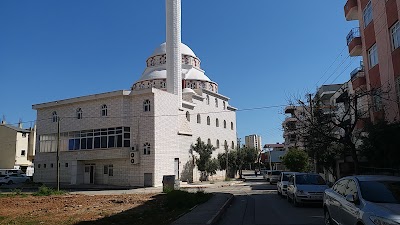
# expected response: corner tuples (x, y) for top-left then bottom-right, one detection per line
(165, 0), (182, 108)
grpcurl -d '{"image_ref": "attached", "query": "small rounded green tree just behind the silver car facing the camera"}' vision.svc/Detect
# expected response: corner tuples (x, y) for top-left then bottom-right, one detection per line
(282, 148), (308, 172)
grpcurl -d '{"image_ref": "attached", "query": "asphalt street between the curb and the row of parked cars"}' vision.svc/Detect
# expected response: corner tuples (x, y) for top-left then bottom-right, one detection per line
(218, 176), (324, 225)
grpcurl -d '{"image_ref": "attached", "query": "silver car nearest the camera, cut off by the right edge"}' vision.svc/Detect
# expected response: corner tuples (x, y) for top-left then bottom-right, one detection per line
(324, 175), (400, 225)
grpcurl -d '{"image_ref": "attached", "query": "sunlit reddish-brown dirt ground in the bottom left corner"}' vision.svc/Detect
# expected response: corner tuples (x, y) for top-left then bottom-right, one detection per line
(0, 194), (163, 225)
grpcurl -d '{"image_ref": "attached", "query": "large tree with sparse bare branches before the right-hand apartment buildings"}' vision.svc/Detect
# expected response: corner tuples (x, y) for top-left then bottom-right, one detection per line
(290, 85), (384, 174)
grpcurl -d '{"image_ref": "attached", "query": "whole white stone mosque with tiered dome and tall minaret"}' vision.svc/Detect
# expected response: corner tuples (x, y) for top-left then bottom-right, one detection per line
(32, 0), (237, 186)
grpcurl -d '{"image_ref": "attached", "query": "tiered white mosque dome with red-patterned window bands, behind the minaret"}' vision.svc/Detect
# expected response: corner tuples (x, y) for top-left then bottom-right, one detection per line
(131, 42), (218, 92)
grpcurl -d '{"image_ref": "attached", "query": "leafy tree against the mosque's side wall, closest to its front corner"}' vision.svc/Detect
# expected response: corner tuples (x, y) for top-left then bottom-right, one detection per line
(190, 137), (218, 181)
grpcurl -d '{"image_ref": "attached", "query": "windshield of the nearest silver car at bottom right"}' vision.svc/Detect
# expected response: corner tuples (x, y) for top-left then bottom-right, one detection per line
(360, 181), (400, 204)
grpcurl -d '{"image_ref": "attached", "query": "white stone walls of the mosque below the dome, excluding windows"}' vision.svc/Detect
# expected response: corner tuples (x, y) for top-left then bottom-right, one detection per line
(33, 88), (236, 186)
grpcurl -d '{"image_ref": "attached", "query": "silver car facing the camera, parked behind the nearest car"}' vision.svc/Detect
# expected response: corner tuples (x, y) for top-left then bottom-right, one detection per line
(287, 173), (329, 206)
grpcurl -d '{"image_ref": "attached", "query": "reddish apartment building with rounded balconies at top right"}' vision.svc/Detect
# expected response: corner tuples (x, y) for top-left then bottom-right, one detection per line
(344, 0), (400, 122)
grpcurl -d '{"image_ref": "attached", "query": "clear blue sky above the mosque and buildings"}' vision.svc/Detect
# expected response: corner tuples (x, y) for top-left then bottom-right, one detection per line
(0, 0), (360, 144)
